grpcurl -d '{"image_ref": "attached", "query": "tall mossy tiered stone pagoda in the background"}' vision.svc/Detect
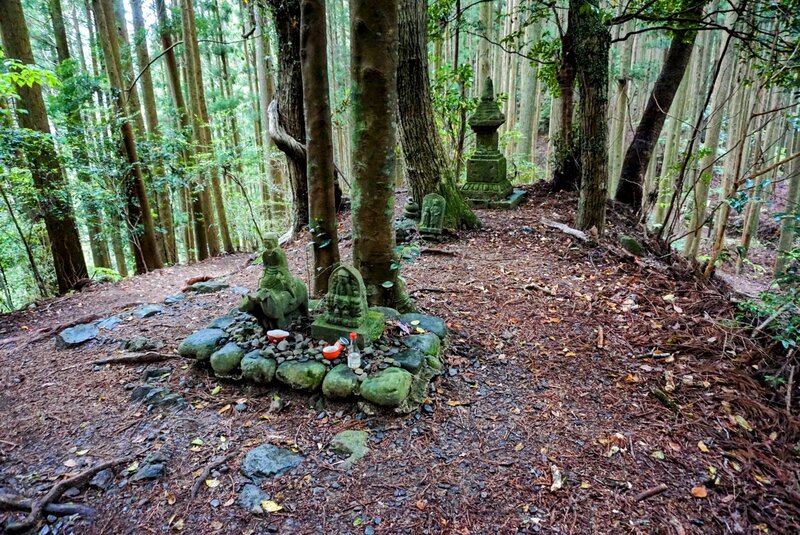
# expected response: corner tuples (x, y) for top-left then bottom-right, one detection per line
(461, 78), (524, 208)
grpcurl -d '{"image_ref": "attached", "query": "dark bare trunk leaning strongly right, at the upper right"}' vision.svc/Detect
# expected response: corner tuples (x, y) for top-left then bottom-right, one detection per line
(617, 0), (705, 212)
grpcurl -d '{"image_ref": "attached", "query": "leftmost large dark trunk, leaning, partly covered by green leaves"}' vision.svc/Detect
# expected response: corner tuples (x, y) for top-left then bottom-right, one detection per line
(0, 0), (87, 293)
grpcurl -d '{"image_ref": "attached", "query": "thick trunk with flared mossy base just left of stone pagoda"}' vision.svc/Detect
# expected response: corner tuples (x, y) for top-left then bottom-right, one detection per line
(397, 0), (480, 228)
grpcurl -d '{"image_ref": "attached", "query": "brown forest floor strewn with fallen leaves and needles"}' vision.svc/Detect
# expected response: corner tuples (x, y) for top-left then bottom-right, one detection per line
(0, 187), (800, 535)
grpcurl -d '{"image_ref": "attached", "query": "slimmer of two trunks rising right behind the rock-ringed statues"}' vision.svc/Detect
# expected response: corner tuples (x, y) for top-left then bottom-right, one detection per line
(300, 0), (339, 296)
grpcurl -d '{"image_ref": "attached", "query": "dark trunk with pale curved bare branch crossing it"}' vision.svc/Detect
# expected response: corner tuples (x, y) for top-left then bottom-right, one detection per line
(267, 0), (308, 231)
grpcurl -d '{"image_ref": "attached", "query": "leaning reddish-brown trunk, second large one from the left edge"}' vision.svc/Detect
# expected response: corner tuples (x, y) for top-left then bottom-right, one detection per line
(92, 0), (161, 273)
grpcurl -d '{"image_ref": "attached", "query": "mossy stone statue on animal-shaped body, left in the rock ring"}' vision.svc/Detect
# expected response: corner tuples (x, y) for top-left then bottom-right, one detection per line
(239, 233), (308, 329)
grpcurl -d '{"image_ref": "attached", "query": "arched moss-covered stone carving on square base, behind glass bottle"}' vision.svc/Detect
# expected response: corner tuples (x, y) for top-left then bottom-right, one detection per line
(311, 265), (384, 347)
